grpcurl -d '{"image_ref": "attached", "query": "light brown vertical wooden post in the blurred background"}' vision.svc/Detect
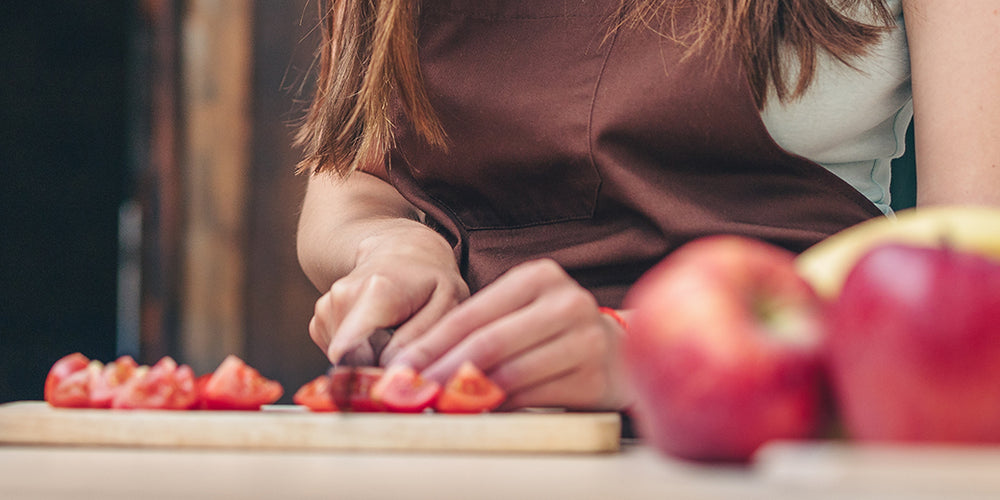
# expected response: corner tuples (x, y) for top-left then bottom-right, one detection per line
(180, 0), (253, 372)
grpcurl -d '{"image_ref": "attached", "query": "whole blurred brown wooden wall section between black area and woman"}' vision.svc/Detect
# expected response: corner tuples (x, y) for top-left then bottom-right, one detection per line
(136, 0), (328, 392)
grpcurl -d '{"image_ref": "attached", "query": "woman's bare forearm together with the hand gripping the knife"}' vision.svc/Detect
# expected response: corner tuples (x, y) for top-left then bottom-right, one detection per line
(298, 172), (469, 362)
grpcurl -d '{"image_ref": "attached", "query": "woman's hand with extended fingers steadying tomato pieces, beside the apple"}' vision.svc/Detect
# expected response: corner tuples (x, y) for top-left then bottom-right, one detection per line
(387, 259), (631, 410)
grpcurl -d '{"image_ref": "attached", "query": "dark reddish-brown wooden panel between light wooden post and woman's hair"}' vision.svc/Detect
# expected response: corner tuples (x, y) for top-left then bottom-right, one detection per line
(246, 0), (329, 390)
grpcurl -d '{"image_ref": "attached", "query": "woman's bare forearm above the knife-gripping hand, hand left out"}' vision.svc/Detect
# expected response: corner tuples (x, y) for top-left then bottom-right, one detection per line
(297, 172), (454, 291)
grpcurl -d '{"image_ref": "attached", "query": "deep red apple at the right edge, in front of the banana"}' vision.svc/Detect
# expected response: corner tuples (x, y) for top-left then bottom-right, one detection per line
(827, 244), (1000, 442)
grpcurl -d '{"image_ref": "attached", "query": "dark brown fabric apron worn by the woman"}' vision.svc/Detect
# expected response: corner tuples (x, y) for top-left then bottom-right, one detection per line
(376, 0), (881, 307)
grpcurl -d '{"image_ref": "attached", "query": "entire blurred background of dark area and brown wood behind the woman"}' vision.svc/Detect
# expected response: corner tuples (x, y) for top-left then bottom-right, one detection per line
(0, 0), (914, 402)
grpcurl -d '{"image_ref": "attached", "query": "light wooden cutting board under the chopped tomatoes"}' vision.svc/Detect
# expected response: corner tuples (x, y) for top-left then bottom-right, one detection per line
(0, 401), (621, 453)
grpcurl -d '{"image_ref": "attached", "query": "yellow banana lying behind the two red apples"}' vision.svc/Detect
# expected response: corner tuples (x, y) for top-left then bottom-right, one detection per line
(795, 206), (1000, 298)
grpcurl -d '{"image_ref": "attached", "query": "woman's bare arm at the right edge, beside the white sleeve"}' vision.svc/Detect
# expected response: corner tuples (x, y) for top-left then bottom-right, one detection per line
(903, 0), (1000, 205)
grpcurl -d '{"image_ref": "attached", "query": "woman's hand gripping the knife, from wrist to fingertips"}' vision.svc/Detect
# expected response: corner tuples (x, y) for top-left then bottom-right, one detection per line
(309, 225), (469, 364)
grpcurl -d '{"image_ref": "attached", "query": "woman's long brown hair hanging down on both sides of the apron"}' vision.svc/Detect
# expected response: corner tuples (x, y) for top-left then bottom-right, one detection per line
(296, 0), (892, 175)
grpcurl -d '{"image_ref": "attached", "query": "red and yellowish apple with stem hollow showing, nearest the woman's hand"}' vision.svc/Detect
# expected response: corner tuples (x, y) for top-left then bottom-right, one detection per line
(623, 235), (827, 461)
